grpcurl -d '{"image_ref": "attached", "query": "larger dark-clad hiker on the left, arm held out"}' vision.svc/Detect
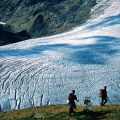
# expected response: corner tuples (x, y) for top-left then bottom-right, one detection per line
(68, 90), (79, 116)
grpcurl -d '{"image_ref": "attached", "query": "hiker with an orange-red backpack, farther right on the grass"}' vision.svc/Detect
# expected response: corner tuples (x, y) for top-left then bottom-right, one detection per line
(100, 86), (108, 106)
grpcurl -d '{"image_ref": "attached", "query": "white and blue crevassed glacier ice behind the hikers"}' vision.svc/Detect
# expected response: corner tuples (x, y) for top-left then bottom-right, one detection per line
(0, 0), (120, 111)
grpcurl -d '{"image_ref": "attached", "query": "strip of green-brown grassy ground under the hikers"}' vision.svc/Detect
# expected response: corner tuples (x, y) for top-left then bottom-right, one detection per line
(0, 104), (120, 120)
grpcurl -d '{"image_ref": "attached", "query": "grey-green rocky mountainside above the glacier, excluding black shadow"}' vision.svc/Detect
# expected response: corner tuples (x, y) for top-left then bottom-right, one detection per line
(0, 0), (96, 45)
